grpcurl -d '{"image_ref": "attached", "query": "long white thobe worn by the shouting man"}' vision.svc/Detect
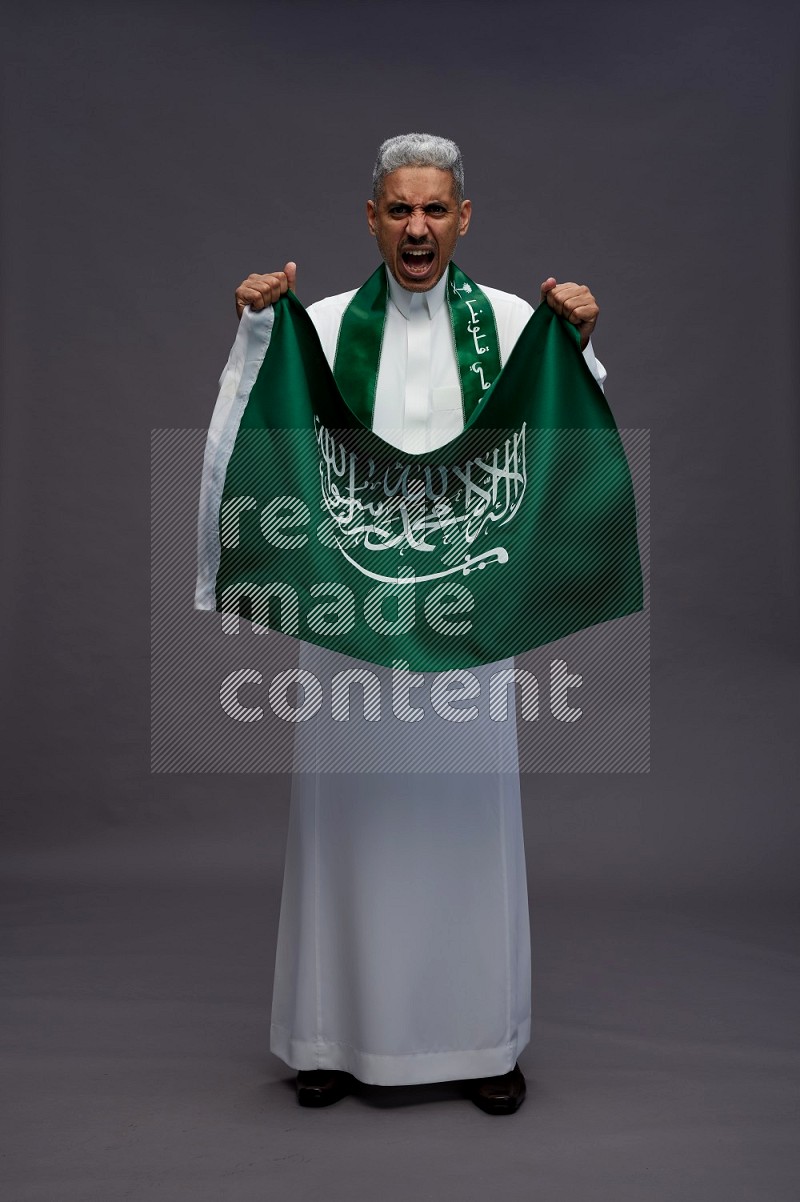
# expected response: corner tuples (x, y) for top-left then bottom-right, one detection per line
(270, 275), (605, 1085)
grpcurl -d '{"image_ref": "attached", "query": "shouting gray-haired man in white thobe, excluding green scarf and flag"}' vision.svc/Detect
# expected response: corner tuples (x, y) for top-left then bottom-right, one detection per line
(227, 133), (605, 1114)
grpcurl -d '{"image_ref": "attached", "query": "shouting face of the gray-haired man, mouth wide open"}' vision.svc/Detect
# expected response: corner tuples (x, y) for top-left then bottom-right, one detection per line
(366, 167), (472, 292)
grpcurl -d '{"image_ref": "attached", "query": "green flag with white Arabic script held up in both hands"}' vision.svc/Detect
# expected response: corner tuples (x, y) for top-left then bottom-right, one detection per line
(196, 282), (643, 672)
